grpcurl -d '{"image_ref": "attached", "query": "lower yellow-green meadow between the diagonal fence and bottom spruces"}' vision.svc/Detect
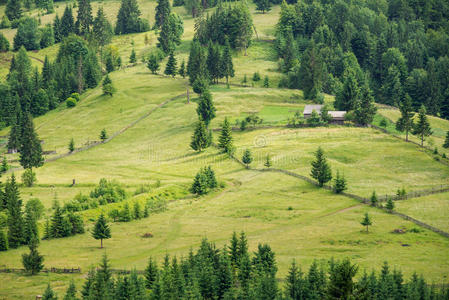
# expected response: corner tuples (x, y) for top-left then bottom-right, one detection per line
(0, 170), (449, 299)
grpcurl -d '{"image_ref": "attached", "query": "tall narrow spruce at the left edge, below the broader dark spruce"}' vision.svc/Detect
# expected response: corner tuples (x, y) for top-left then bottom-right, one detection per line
(5, 174), (24, 248)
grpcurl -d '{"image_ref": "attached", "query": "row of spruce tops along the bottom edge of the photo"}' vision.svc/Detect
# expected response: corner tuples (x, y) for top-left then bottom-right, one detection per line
(43, 232), (449, 300)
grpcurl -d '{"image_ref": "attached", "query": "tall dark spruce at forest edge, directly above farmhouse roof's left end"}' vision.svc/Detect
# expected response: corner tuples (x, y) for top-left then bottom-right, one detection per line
(298, 41), (323, 100)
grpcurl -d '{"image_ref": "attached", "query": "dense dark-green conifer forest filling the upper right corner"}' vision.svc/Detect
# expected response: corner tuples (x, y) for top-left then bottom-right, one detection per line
(275, 0), (449, 118)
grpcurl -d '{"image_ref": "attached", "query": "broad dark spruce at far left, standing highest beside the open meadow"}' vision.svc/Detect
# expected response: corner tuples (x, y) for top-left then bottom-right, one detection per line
(19, 113), (44, 169)
